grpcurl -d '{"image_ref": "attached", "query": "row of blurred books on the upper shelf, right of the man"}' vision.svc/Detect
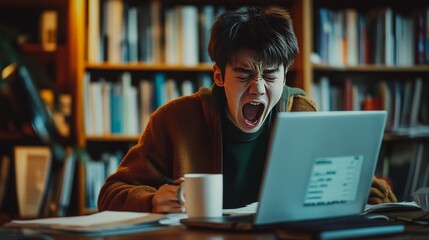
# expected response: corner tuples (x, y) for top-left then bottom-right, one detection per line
(315, 7), (429, 66)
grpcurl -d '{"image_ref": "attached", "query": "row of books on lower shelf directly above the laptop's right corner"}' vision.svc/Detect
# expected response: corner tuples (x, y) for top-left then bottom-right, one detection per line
(312, 77), (429, 136)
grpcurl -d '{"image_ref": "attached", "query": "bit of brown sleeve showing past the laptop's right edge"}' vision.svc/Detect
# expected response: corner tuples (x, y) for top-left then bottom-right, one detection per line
(368, 177), (398, 204)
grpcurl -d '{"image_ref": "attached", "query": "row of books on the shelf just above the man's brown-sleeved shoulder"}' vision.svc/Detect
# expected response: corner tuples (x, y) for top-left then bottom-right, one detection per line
(84, 72), (212, 136)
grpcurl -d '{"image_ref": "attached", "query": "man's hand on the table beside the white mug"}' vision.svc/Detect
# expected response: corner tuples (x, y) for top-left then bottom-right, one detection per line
(152, 178), (185, 213)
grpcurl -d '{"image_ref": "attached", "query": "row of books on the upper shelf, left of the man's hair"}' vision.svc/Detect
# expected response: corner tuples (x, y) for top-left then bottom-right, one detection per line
(87, 0), (225, 66)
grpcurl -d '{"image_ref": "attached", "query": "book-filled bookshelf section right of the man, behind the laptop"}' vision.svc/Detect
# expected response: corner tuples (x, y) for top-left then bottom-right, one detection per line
(309, 0), (429, 200)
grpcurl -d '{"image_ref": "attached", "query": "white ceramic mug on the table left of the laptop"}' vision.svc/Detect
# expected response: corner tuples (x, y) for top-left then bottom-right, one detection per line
(178, 173), (223, 218)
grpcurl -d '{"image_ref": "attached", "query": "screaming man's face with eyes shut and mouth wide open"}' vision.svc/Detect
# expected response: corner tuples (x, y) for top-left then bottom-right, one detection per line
(214, 51), (286, 133)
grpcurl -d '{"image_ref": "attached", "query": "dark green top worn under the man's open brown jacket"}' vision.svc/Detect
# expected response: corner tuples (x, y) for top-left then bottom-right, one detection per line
(222, 112), (271, 208)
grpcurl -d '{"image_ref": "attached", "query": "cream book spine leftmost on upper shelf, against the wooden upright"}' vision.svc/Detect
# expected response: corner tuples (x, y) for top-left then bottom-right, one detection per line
(87, 0), (101, 63)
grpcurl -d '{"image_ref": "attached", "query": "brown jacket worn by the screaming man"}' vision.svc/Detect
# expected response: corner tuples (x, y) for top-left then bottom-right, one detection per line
(98, 86), (394, 212)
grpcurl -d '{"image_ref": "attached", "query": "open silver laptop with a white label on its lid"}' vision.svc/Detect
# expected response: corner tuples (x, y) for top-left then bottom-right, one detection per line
(181, 111), (403, 234)
